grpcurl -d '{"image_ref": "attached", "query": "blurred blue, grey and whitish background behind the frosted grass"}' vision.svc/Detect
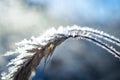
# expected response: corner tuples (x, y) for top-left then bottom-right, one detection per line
(0, 0), (120, 80)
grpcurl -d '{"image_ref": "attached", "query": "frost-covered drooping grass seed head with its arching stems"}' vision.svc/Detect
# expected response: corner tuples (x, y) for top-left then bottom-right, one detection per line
(1, 26), (120, 80)
